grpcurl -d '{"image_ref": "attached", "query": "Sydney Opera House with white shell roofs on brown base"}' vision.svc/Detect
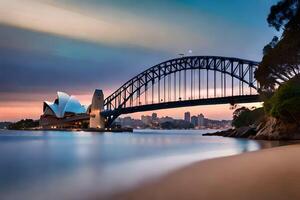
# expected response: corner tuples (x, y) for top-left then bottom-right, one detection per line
(40, 92), (90, 129)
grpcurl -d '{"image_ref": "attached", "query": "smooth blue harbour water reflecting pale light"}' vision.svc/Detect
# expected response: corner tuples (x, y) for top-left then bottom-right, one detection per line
(0, 130), (286, 200)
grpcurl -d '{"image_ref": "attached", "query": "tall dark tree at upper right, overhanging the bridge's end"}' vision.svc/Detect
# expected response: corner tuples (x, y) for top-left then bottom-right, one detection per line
(255, 0), (300, 91)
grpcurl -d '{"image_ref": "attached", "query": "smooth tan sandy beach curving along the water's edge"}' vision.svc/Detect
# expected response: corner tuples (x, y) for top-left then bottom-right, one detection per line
(112, 144), (300, 200)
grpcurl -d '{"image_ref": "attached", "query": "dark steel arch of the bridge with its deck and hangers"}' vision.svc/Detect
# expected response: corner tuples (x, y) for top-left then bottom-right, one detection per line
(101, 56), (259, 125)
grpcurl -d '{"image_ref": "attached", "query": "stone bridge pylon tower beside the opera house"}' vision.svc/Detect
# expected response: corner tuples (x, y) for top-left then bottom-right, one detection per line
(90, 89), (105, 129)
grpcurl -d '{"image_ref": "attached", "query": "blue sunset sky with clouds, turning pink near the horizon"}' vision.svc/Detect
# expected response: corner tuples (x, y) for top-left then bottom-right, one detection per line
(0, 0), (277, 121)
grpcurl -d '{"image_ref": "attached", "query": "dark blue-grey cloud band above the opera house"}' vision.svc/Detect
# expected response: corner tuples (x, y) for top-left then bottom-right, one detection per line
(0, 25), (169, 101)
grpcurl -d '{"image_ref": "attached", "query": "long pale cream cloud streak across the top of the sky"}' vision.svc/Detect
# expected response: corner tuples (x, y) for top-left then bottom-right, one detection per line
(0, 0), (205, 50)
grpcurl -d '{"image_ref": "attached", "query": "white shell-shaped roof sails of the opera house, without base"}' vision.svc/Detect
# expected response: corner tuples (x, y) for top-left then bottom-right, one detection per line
(44, 92), (87, 118)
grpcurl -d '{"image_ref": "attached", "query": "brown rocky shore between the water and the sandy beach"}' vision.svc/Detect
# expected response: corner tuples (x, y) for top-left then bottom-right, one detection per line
(203, 117), (300, 140)
